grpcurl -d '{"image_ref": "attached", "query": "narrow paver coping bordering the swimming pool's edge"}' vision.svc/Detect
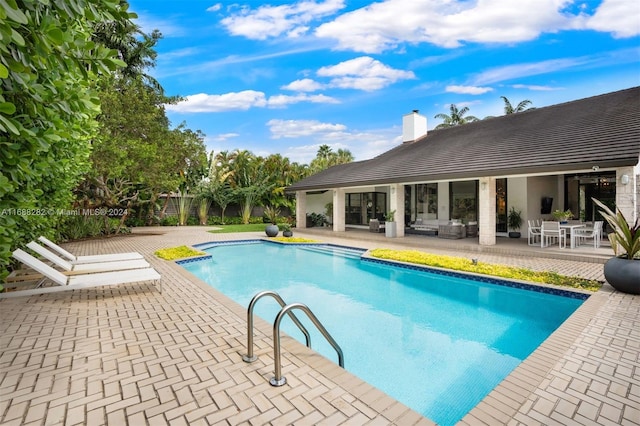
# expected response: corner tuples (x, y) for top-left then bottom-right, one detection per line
(176, 239), (596, 426)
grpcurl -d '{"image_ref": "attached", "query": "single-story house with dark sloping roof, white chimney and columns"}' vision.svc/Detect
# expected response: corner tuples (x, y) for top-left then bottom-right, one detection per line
(287, 87), (640, 245)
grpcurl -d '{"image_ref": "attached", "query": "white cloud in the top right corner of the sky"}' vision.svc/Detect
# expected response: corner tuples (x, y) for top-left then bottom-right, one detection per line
(585, 0), (640, 38)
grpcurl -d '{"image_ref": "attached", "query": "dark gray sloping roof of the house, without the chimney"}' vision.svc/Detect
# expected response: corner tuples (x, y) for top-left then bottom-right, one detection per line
(287, 87), (640, 191)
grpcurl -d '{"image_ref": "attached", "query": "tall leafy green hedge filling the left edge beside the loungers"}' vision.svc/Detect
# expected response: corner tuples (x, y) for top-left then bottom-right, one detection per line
(0, 0), (132, 275)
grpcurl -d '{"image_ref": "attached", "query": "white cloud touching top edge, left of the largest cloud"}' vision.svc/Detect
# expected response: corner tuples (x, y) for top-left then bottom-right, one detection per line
(221, 0), (345, 40)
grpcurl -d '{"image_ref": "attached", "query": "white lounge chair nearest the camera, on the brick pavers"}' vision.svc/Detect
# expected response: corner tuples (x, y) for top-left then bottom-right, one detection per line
(0, 249), (162, 299)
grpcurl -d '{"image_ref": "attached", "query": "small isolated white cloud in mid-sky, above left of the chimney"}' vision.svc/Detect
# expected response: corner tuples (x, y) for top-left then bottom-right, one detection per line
(317, 56), (416, 91)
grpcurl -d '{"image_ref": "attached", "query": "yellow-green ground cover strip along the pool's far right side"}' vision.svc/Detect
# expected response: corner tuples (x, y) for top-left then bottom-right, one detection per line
(369, 249), (602, 291)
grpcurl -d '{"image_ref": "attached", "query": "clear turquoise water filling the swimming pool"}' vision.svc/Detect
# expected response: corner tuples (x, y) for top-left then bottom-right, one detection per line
(182, 242), (585, 425)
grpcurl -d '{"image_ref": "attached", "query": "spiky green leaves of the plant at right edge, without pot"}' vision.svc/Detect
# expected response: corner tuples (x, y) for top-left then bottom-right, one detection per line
(592, 198), (640, 259)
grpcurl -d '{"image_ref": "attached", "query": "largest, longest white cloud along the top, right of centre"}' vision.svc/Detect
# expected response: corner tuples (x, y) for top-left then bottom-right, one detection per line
(315, 0), (604, 53)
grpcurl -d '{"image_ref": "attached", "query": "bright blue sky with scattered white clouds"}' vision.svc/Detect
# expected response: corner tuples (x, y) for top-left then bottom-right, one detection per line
(129, 0), (640, 163)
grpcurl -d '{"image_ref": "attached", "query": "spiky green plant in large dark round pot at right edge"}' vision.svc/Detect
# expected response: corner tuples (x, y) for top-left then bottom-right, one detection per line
(592, 198), (640, 294)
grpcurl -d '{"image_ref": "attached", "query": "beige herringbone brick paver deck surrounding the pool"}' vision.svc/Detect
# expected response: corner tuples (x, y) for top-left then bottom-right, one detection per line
(0, 227), (640, 426)
